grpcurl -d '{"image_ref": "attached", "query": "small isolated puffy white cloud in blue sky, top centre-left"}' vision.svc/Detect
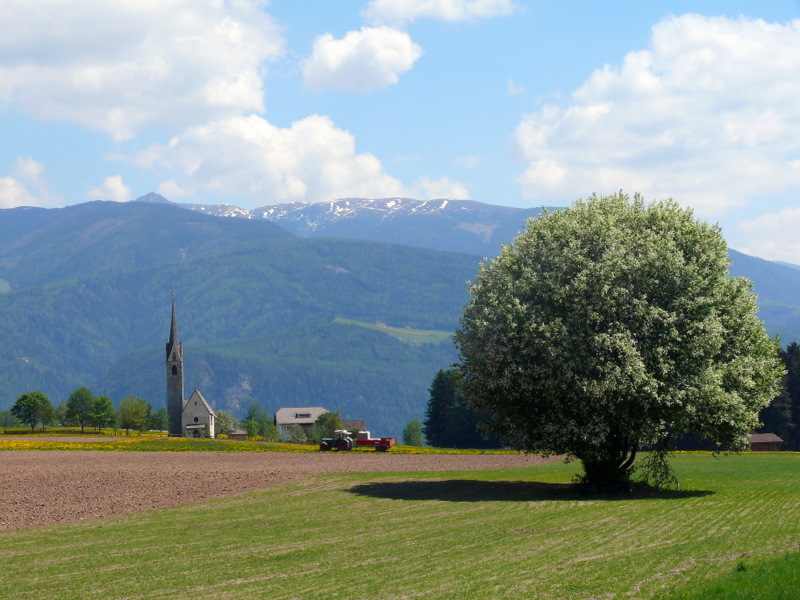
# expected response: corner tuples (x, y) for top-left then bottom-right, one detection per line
(303, 27), (422, 92)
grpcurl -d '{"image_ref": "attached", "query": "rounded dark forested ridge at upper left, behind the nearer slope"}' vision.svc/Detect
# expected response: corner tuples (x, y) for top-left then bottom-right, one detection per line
(0, 202), (293, 289)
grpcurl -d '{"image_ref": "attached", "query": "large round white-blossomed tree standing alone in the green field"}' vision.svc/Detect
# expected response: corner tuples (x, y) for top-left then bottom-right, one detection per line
(455, 192), (782, 487)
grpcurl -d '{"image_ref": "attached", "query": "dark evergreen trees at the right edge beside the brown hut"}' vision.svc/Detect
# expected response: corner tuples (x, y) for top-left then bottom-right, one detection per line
(759, 342), (800, 452)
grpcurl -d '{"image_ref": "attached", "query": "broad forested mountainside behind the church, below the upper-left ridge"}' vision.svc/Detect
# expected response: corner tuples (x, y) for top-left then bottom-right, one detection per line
(0, 212), (478, 433)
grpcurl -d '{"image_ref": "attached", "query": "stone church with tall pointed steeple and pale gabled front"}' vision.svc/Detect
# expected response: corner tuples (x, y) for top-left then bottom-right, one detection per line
(167, 294), (216, 438)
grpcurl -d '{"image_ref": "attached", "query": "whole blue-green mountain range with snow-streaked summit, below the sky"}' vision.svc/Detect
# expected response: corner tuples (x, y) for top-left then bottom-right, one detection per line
(0, 194), (800, 435)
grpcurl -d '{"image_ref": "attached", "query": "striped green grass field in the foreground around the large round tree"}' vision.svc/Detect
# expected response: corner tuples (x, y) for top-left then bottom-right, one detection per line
(0, 454), (800, 600)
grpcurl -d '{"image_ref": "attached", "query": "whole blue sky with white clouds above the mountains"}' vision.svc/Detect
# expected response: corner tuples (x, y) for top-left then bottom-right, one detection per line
(0, 0), (800, 263)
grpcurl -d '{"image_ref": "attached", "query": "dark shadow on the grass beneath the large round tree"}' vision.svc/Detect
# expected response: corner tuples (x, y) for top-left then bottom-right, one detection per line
(349, 479), (714, 502)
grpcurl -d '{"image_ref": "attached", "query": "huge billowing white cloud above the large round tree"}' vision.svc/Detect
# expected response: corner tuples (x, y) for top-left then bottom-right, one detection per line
(514, 14), (800, 215)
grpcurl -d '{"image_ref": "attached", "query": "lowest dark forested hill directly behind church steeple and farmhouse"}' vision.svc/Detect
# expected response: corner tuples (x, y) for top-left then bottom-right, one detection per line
(97, 316), (456, 435)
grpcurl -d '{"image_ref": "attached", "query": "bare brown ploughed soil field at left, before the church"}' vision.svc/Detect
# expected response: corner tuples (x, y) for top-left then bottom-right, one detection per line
(0, 450), (553, 530)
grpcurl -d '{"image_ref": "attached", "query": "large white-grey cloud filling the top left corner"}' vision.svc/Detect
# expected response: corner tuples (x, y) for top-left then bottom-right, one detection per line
(0, 0), (283, 140)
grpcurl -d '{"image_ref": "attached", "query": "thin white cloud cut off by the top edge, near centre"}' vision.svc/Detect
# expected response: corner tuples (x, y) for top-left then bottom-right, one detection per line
(361, 0), (518, 27)
